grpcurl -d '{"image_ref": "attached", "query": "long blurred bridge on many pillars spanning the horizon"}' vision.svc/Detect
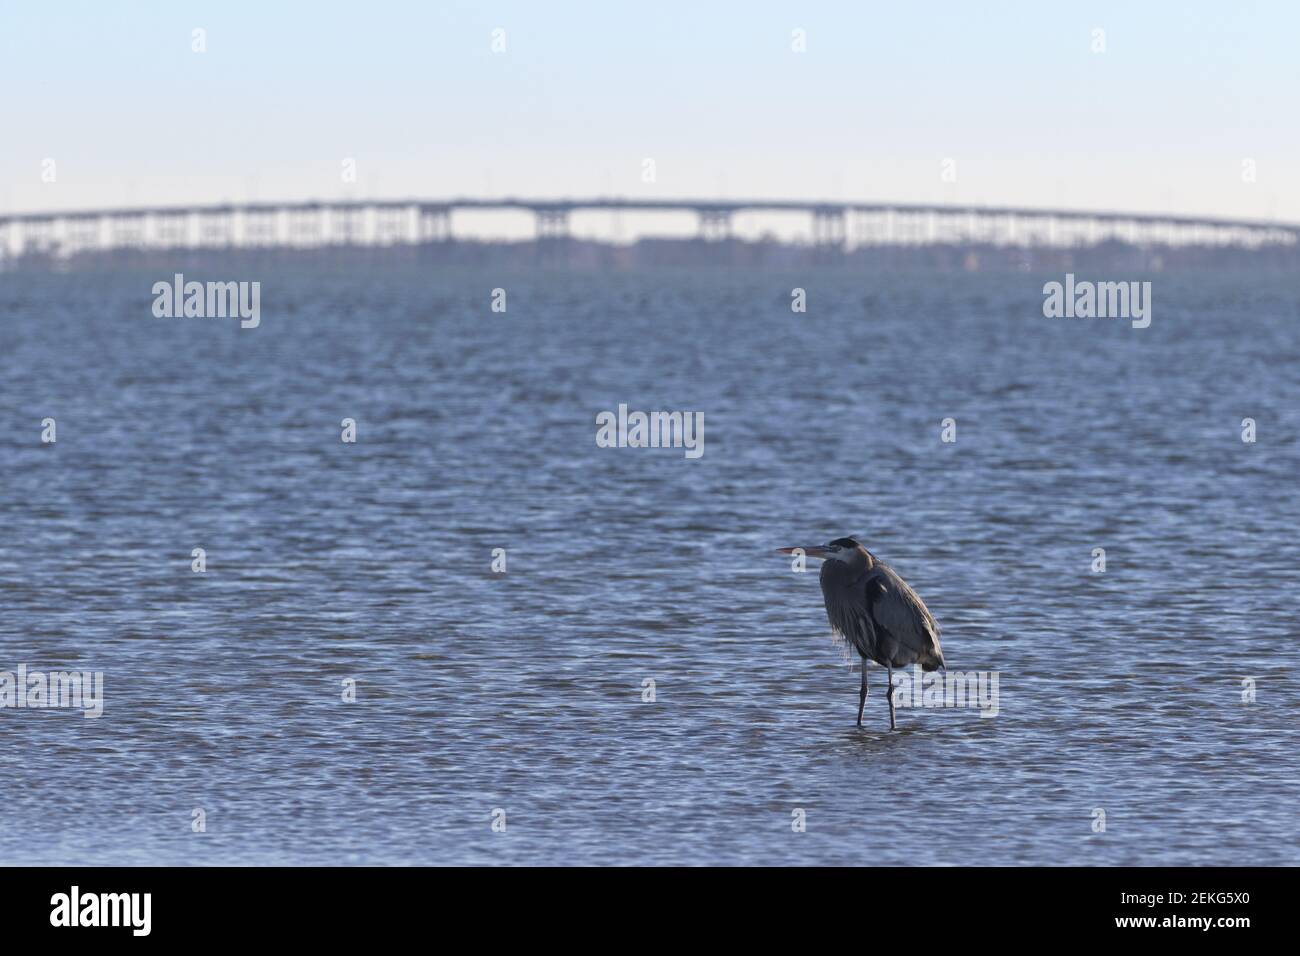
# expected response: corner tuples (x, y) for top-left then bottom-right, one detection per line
(0, 198), (1300, 259)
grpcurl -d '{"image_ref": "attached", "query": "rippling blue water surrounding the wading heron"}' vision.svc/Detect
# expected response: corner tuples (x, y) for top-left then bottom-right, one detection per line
(0, 264), (1300, 865)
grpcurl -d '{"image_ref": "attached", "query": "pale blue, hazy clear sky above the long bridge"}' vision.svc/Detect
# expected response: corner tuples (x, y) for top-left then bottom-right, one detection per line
(0, 0), (1300, 234)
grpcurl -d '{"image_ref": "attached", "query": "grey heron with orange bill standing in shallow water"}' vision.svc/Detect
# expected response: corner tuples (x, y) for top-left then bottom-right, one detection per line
(779, 537), (944, 730)
